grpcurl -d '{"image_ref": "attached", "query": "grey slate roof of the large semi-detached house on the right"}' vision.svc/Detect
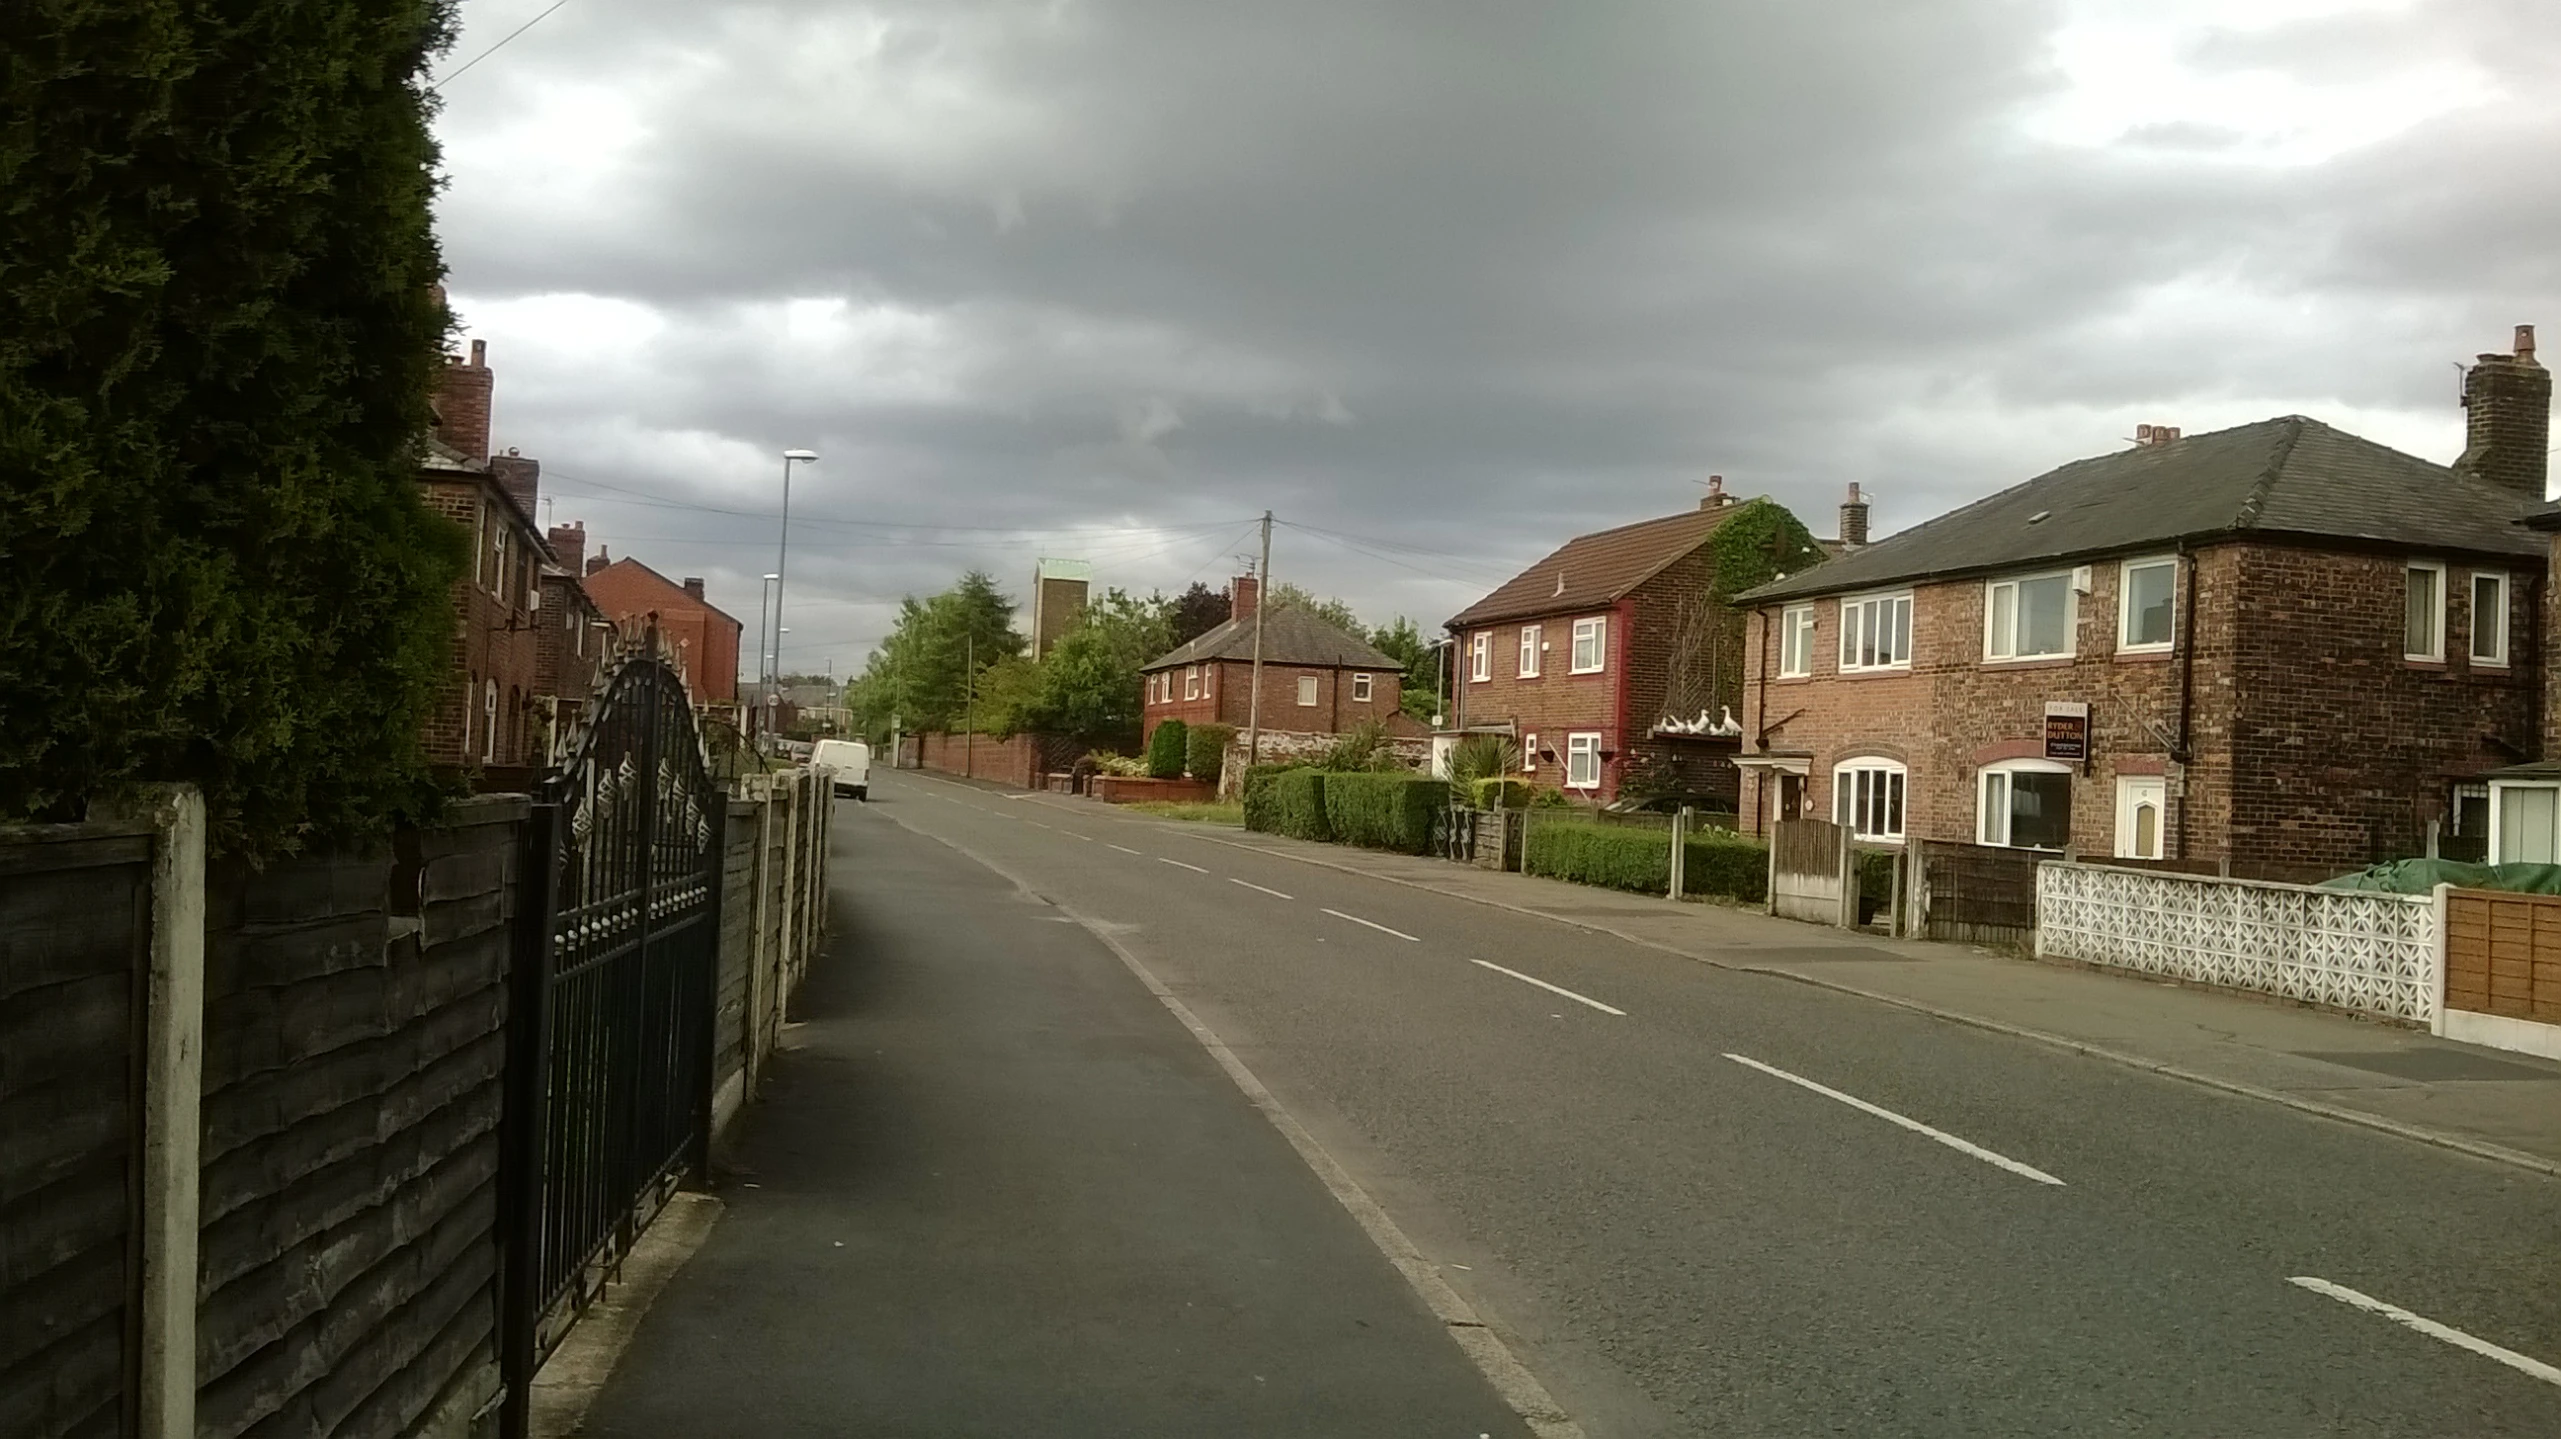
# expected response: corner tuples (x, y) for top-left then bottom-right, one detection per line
(1739, 415), (2546, 602)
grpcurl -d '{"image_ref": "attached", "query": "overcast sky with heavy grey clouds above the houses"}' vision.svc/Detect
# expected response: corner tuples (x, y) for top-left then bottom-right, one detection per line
(440, 0), (2561, 673)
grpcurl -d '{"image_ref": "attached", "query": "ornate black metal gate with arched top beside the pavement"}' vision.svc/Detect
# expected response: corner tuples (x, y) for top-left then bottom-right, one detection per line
(502, 653), (725, 1434)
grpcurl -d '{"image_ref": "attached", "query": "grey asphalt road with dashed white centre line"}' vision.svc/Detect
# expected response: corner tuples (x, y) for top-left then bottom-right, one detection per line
(865, 773), (2561, 1439)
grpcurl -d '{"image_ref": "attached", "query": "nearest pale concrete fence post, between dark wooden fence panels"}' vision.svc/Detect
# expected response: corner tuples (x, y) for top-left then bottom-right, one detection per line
(125, 784), (205, 1439)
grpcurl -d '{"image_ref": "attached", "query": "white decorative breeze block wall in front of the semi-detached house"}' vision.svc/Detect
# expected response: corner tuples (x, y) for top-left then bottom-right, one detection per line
(2036, 863), (2443, 1024)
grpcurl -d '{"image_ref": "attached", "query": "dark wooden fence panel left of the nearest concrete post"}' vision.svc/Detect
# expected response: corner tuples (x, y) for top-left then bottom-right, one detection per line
(0, 824), (151, 1439)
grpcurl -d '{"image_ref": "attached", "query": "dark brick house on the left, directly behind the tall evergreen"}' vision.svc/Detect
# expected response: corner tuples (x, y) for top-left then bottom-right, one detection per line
(417, 341), (553, 768)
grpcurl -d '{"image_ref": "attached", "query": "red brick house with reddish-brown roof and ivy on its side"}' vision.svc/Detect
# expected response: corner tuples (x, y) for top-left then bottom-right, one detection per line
(1450, 479), (1823, 809)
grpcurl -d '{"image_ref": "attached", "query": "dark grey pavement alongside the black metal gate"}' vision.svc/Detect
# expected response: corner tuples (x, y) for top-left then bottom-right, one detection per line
(581, 783), (1529, 1439)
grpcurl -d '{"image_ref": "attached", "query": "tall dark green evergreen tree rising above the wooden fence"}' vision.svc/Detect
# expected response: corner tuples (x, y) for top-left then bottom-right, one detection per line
(0, 0), (466, 853)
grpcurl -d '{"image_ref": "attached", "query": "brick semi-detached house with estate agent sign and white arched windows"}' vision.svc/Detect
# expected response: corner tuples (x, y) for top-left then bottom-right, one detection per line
(1739, 330), (2551, 873)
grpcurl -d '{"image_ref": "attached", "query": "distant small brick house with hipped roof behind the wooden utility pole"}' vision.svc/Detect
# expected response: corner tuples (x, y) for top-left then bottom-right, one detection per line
(1140, 576), (1419, 735)
